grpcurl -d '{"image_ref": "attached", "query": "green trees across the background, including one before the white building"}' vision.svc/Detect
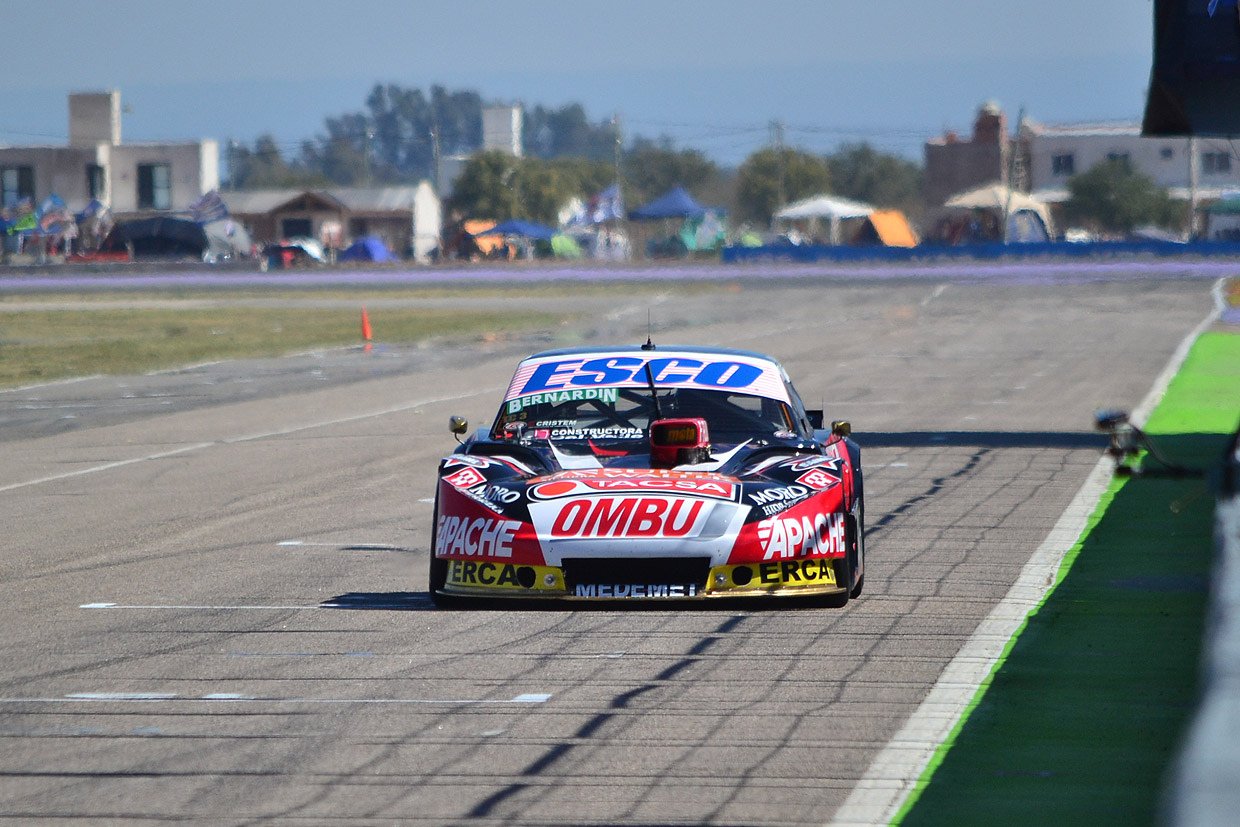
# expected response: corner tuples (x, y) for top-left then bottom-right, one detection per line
(228, 84), (1184, 232)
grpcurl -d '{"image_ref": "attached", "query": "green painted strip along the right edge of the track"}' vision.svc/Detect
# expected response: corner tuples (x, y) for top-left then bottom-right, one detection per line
(894, 332), (1240, 827)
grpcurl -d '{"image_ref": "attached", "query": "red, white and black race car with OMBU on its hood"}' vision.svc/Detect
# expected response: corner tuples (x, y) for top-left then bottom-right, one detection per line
(429, 341), (866, 606)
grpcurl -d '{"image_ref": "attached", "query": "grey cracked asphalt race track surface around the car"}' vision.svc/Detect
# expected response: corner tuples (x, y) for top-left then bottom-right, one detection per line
(0, 265), (1214, 825)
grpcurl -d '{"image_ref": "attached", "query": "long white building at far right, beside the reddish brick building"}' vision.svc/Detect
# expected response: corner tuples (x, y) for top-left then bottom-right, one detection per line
(1022, 122), (1240, 202)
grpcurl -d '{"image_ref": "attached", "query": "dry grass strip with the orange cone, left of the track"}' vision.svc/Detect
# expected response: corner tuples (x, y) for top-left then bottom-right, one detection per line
(0, 303), (570, 387)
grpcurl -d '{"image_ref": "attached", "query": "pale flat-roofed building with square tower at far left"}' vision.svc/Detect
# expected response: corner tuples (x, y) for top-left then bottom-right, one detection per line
(0, 89), (219, 214)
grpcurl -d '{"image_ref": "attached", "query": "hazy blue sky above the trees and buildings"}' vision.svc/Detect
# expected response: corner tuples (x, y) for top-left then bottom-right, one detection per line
(0, 0), (1153, 165)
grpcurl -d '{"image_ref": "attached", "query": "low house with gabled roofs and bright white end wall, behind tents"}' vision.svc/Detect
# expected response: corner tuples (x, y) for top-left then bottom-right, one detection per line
(221, 181), (443, 260)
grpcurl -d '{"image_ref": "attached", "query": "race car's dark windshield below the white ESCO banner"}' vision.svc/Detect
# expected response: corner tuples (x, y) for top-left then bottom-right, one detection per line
(494, 388), (795, 450)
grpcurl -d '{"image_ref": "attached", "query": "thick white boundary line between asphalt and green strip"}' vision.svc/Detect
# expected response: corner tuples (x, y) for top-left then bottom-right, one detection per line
(830, 279), (1223, 827)
